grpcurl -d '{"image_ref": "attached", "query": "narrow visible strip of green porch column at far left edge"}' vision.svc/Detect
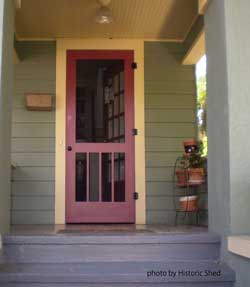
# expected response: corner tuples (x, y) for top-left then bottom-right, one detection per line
(0, 0), (14, 233)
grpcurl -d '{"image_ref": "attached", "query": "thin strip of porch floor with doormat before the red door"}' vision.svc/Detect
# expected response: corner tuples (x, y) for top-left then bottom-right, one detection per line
(10, 224), (208, 235)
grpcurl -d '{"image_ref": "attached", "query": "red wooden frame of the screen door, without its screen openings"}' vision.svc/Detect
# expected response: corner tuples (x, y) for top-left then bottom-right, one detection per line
(65, 50), (135, 223)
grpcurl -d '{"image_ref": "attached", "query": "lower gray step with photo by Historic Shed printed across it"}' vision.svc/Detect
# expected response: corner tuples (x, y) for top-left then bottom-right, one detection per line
(0, 261), (235, 287)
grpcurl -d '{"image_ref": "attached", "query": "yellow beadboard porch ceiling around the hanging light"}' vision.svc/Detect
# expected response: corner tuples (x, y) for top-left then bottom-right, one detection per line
(16, 0), (198, 41)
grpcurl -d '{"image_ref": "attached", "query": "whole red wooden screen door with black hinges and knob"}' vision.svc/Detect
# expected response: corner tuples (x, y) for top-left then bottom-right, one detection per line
(66, 50), (135, 223)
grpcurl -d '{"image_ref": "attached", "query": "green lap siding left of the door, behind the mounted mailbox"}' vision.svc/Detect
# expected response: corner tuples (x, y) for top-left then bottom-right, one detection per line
(11, 42), (56, 224)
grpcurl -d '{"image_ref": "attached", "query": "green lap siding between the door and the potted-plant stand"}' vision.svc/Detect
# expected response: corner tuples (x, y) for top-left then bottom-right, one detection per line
(145, 42), (196, 225)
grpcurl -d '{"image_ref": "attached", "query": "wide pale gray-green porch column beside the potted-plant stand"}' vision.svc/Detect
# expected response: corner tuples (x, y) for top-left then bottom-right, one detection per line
(205, 0), (250, 286)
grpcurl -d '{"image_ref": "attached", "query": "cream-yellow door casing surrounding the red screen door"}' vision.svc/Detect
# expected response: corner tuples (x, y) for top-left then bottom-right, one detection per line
(54, 38), (146, 224)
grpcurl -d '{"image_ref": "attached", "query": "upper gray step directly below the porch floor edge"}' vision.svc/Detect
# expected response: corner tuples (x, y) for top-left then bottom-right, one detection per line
(3, 233), (220, 263)
